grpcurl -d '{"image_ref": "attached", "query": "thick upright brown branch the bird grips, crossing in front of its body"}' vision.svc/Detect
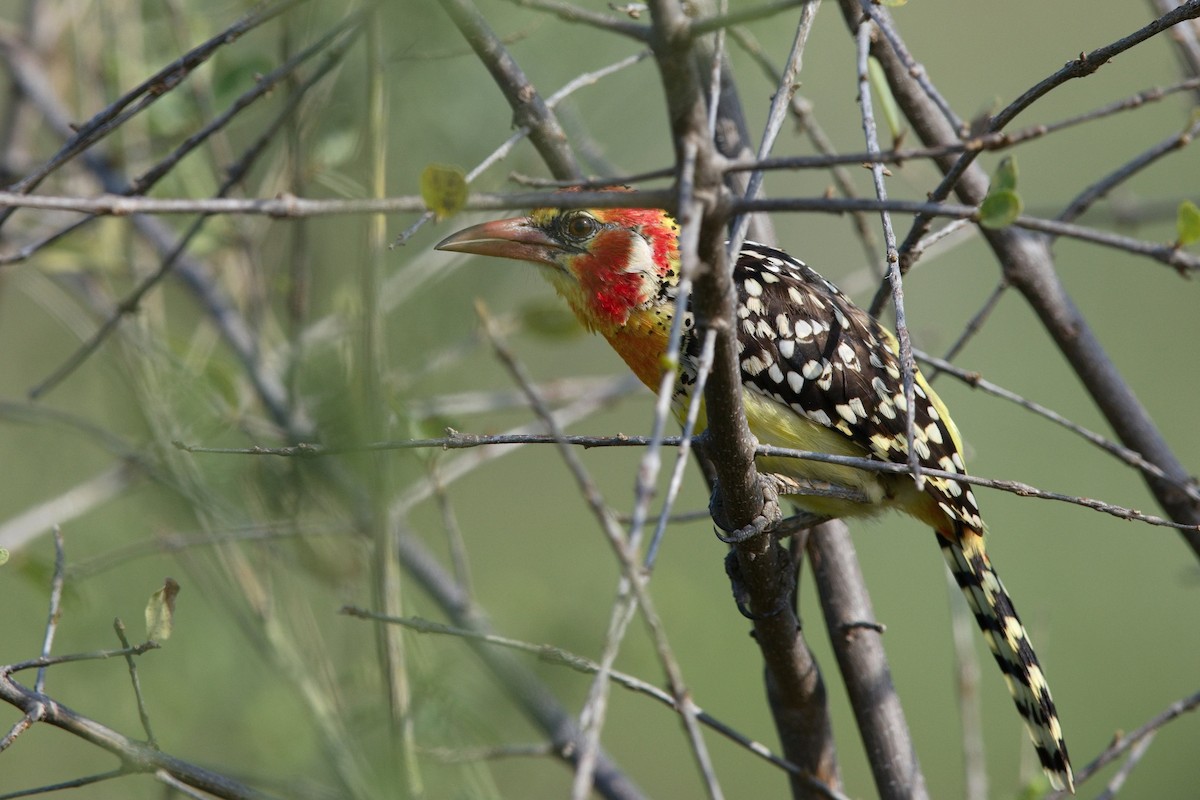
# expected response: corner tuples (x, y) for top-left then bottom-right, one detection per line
(650, 0), (840, 798)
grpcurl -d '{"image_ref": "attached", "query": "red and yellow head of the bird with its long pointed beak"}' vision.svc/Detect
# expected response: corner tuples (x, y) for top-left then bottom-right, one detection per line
(437, 203), (679, 333)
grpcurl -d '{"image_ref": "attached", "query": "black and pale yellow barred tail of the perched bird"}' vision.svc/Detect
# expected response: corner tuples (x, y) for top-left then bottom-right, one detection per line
(937, 524), (1075, 794)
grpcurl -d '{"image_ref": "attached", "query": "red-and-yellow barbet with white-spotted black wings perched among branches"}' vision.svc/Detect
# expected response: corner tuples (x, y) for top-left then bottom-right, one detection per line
(437, 195), (1074, 793)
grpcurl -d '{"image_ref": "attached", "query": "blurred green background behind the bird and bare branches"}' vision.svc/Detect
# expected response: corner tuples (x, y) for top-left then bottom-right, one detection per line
(0, 0), (1200, 798)
